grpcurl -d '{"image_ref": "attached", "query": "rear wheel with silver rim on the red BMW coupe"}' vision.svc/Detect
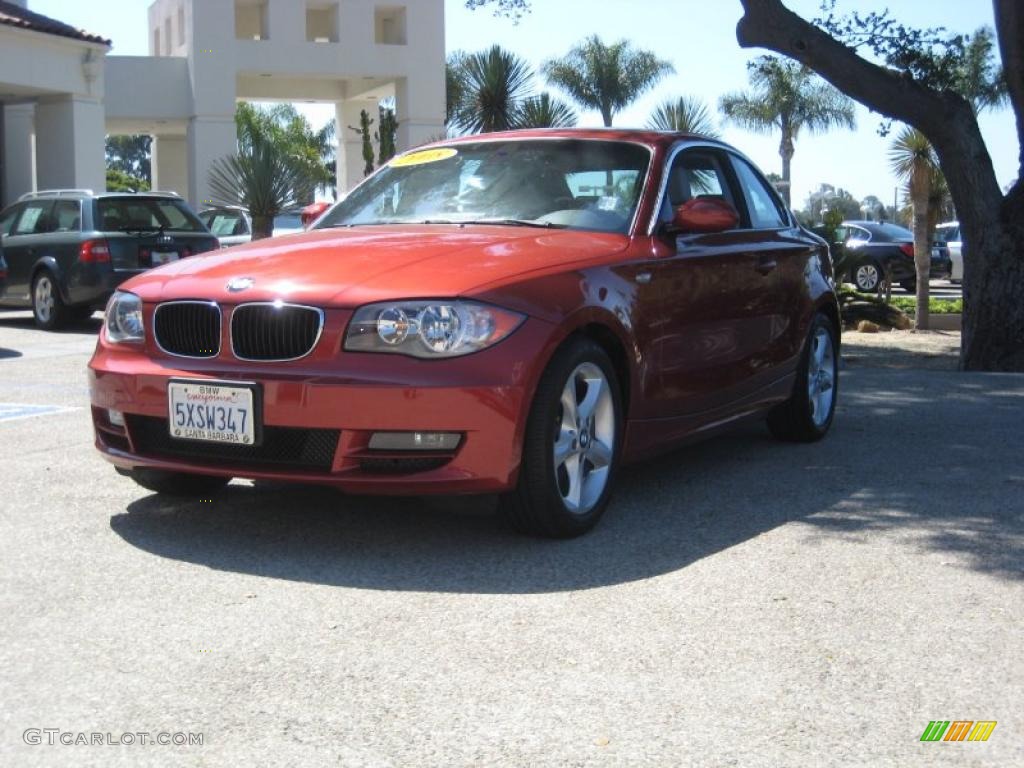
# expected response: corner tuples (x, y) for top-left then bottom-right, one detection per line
(768, 314), (839, 442)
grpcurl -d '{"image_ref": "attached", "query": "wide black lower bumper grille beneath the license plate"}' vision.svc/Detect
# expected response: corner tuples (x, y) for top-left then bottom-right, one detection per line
(127, 415), (341, 472)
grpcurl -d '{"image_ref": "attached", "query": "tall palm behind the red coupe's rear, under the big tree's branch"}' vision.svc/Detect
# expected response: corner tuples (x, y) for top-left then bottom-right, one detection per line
(720, 56), (856, 206)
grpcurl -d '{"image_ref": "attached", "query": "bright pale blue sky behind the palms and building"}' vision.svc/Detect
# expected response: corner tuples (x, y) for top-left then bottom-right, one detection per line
(29, 0), (1018, 207)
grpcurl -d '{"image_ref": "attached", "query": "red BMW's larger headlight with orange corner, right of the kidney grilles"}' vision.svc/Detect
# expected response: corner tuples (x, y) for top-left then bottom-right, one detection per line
(345, 299), (523, 358)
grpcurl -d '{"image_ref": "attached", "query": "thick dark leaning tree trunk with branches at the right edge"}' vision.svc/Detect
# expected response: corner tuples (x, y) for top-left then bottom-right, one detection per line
(736, 0), (1024, 371)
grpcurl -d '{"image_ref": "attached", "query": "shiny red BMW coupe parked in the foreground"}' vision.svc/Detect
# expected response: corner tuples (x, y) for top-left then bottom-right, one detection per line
(89, 130), (840, 537)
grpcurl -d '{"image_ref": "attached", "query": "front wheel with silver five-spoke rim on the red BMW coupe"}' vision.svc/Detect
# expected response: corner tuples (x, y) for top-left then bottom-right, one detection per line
(501, 338), (623, 539)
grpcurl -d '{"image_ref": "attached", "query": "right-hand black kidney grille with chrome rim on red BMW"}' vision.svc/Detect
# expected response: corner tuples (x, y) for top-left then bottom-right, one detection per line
(231, 303), (324, 360)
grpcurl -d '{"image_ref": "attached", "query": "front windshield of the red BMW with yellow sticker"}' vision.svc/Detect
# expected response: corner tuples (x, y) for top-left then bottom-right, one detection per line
(316, 139), (650, 232)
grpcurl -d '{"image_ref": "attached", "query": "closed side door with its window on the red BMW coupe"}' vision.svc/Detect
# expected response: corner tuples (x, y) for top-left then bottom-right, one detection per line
(634, 146), (770, 418)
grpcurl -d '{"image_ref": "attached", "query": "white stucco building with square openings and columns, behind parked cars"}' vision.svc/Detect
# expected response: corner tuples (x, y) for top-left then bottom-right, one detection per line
(0, 0), (444, 207)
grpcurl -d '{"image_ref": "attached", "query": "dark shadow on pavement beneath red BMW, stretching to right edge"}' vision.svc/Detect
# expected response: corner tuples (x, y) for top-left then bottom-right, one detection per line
(111, 371), (1024, 593)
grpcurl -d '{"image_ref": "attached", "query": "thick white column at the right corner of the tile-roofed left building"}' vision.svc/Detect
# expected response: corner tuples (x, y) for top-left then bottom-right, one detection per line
(36, 96), (106, 193)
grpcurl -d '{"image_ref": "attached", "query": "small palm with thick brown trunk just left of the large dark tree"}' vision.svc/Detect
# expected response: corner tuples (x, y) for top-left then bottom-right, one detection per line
(889, 126), (939, 330)
